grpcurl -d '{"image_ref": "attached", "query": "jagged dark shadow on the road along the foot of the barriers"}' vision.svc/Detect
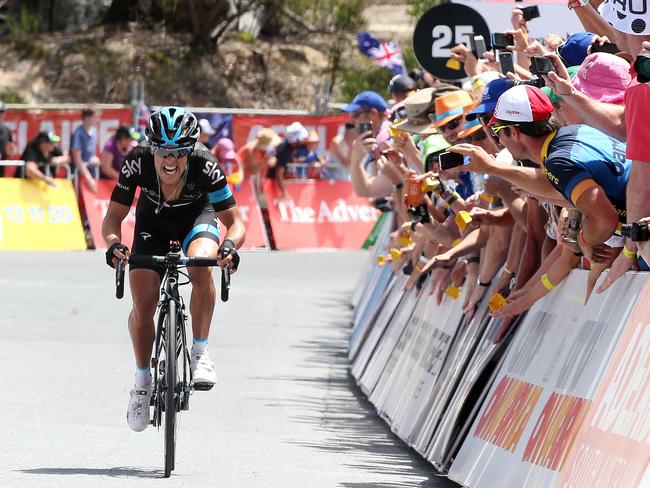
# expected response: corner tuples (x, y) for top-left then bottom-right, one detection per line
(251, 293), (459, 488)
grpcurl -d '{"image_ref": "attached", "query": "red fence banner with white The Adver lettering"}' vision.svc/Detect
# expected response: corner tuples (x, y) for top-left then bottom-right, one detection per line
(264, 181), (379, 249)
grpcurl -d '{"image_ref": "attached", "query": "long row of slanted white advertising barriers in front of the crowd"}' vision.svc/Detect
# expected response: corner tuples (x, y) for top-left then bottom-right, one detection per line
(349, 215), (650, 488)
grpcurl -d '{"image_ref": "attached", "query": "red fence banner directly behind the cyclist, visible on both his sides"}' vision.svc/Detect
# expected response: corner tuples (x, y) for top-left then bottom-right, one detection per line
(80, 180), (269, 249)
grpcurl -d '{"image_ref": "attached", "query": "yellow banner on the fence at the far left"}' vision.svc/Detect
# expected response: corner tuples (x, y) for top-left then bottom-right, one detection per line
(0, 178), (86, 251)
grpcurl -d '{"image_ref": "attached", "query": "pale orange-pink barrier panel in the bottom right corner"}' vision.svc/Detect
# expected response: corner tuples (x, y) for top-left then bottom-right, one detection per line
(556, 274), (650, 488)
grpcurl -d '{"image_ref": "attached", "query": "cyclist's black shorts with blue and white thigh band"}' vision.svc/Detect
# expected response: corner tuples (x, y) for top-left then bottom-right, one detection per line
(129, 201), (220, 280)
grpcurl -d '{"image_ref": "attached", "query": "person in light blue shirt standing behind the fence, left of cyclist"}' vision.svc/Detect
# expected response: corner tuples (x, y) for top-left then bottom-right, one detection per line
(70, 108), (99, 193)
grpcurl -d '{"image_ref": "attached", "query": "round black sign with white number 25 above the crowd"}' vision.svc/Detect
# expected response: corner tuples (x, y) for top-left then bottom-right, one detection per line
(413, 3), (490, 81)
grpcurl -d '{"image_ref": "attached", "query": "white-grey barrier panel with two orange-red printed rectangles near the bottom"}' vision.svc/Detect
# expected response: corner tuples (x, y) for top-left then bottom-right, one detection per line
(449, 270), (647, 488)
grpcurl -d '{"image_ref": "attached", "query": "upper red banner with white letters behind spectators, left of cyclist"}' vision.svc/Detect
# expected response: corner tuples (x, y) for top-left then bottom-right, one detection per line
(5, 108), (132, 158)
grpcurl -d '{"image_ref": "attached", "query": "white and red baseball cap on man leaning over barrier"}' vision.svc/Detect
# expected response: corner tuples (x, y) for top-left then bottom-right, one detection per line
(488, 85), (553, 125)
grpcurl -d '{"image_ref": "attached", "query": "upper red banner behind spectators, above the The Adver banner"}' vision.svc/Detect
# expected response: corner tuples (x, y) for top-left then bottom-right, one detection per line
(232, 114), (350, 153)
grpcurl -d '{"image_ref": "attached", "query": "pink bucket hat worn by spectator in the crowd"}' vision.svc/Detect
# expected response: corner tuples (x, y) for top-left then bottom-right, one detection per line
(573, 52), (632, 104)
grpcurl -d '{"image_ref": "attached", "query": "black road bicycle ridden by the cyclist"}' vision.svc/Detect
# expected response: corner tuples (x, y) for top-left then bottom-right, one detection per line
(115, 241), (234, 478)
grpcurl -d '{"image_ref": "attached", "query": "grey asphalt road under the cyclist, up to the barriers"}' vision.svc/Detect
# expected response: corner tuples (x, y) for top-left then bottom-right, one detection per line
(0, 252), (456, 488)
